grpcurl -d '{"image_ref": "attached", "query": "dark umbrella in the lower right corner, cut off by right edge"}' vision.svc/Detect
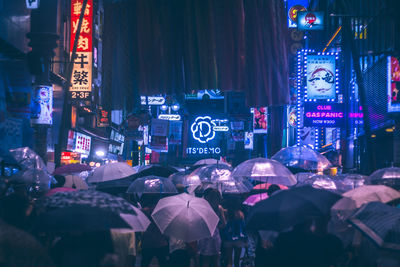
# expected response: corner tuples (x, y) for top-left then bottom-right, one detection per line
(349, 202), (400, 250)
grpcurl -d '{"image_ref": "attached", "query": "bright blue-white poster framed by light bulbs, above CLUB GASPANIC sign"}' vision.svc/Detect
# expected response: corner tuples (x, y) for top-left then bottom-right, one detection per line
(307, 55), (336, 99)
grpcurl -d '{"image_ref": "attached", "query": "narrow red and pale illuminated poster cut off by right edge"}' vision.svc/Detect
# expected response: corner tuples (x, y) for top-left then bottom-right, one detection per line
(388, 57), (400, 112)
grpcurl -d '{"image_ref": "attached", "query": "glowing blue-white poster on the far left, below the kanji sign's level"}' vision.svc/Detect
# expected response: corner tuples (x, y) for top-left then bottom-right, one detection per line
(31, 85), (53, 125)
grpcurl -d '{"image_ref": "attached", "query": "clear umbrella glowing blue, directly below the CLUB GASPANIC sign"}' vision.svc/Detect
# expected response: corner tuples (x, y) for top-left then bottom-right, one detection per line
(272, 146), (332, 170)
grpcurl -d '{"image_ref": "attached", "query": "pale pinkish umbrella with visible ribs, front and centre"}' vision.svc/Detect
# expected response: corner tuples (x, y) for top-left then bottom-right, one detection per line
(151, 193), (219, 242)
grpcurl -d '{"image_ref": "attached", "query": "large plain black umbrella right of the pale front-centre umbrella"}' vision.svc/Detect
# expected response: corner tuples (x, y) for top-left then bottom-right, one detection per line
(247, 186), (341, 231)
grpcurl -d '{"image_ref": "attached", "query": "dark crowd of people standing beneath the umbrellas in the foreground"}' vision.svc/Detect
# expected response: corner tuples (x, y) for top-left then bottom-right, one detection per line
(0, 170), (400, 267)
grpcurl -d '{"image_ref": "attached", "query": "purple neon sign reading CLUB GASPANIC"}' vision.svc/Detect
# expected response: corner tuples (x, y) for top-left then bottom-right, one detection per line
(304, 103), (344, 127)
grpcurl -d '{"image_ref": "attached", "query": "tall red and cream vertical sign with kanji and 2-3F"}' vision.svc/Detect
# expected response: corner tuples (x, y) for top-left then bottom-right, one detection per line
(69, 0), (93, 100)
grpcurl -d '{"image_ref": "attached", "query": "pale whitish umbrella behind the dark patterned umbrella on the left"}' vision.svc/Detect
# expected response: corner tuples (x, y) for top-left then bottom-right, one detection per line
(87, 162), (136, 183)
